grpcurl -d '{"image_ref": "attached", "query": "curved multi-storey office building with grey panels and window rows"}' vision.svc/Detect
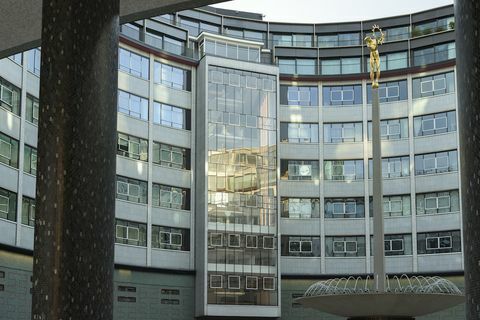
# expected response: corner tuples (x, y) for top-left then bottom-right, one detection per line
(0, 6), (464, 320)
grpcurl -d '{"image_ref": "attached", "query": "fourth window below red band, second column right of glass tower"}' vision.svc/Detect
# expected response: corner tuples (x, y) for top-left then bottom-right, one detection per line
(324, 198), (365, 219)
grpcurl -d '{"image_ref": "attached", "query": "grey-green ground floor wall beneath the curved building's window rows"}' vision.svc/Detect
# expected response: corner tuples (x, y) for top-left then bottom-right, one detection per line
(0, 250), (466, 320)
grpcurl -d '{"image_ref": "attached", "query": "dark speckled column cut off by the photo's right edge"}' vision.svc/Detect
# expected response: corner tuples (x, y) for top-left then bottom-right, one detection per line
(455, 0), (480, 319)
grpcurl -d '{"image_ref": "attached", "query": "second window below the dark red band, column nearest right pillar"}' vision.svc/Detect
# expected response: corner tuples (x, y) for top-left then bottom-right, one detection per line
(413, 111), (457, 137)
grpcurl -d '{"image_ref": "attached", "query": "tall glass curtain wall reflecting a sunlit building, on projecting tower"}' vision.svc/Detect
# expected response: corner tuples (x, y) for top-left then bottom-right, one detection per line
(208, 66), (278, 305)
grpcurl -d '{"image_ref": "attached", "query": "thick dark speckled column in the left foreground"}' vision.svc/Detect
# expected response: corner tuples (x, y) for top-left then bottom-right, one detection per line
(32, 0), (119, 320)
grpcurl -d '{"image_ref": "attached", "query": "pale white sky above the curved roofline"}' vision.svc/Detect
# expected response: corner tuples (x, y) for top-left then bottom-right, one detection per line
(214, 0), (453, 23)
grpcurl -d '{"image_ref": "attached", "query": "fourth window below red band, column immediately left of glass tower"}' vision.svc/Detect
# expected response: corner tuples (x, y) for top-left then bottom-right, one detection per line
(152, 183), (190, 210)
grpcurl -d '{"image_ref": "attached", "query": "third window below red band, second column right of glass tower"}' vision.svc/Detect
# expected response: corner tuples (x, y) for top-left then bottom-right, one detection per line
(324, 160), (363, 181)
